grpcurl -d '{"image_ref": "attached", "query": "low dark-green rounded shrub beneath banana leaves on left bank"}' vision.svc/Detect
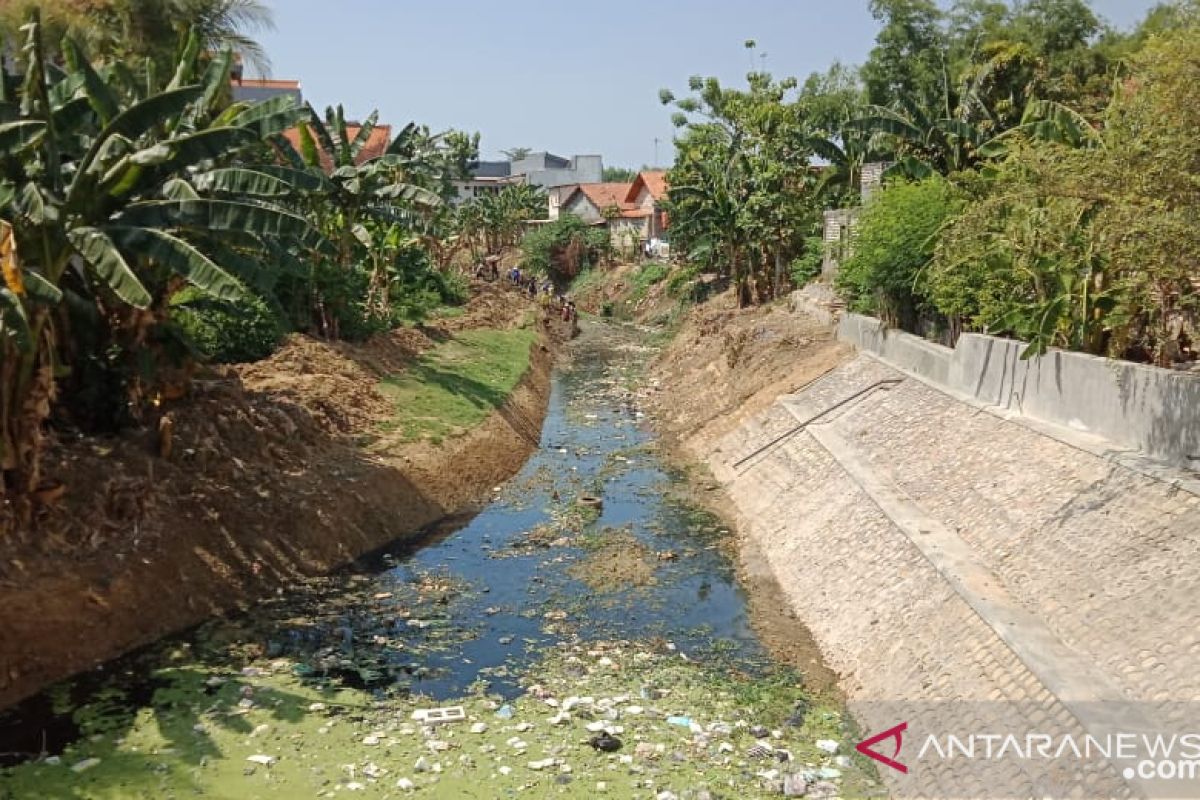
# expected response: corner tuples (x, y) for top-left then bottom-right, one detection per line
(170, 287), (283, 363)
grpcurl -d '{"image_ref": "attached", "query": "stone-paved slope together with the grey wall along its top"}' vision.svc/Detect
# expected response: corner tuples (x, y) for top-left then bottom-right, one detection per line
(707, 315), (1200, 796)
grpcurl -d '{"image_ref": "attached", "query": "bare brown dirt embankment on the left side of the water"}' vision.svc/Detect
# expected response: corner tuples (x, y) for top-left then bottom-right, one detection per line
(0, 284), (551, 706)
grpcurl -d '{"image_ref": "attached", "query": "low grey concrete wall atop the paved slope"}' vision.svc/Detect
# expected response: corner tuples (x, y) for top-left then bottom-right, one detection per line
(838, 314), (1200, 468)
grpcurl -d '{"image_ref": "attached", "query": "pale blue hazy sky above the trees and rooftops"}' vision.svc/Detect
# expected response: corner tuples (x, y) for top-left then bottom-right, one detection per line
(259, 0), (1156, 167)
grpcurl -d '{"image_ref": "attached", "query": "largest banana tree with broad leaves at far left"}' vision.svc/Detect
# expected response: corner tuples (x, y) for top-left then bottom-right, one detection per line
(0, 12), (317, 513)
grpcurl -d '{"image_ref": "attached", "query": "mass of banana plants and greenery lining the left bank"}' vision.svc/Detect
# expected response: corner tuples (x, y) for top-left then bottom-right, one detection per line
(0, 9), (545, 528)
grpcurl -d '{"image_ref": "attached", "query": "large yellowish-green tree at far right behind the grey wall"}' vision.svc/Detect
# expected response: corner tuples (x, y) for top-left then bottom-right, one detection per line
(929, 17), (1200, 365)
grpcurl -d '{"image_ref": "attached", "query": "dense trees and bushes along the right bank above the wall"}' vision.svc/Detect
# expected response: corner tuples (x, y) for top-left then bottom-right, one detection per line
(661, 0), (1200, 366)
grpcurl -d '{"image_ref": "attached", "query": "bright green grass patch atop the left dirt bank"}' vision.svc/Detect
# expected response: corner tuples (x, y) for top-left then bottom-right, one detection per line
(379, 329), (535, 444)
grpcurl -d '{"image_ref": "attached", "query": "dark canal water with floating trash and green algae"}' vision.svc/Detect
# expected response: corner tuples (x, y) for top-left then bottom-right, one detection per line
(0, 323), (870, 798)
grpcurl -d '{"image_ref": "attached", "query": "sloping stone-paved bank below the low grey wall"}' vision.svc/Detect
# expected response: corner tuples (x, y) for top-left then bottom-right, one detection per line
(710, 356), (1200, 796)
